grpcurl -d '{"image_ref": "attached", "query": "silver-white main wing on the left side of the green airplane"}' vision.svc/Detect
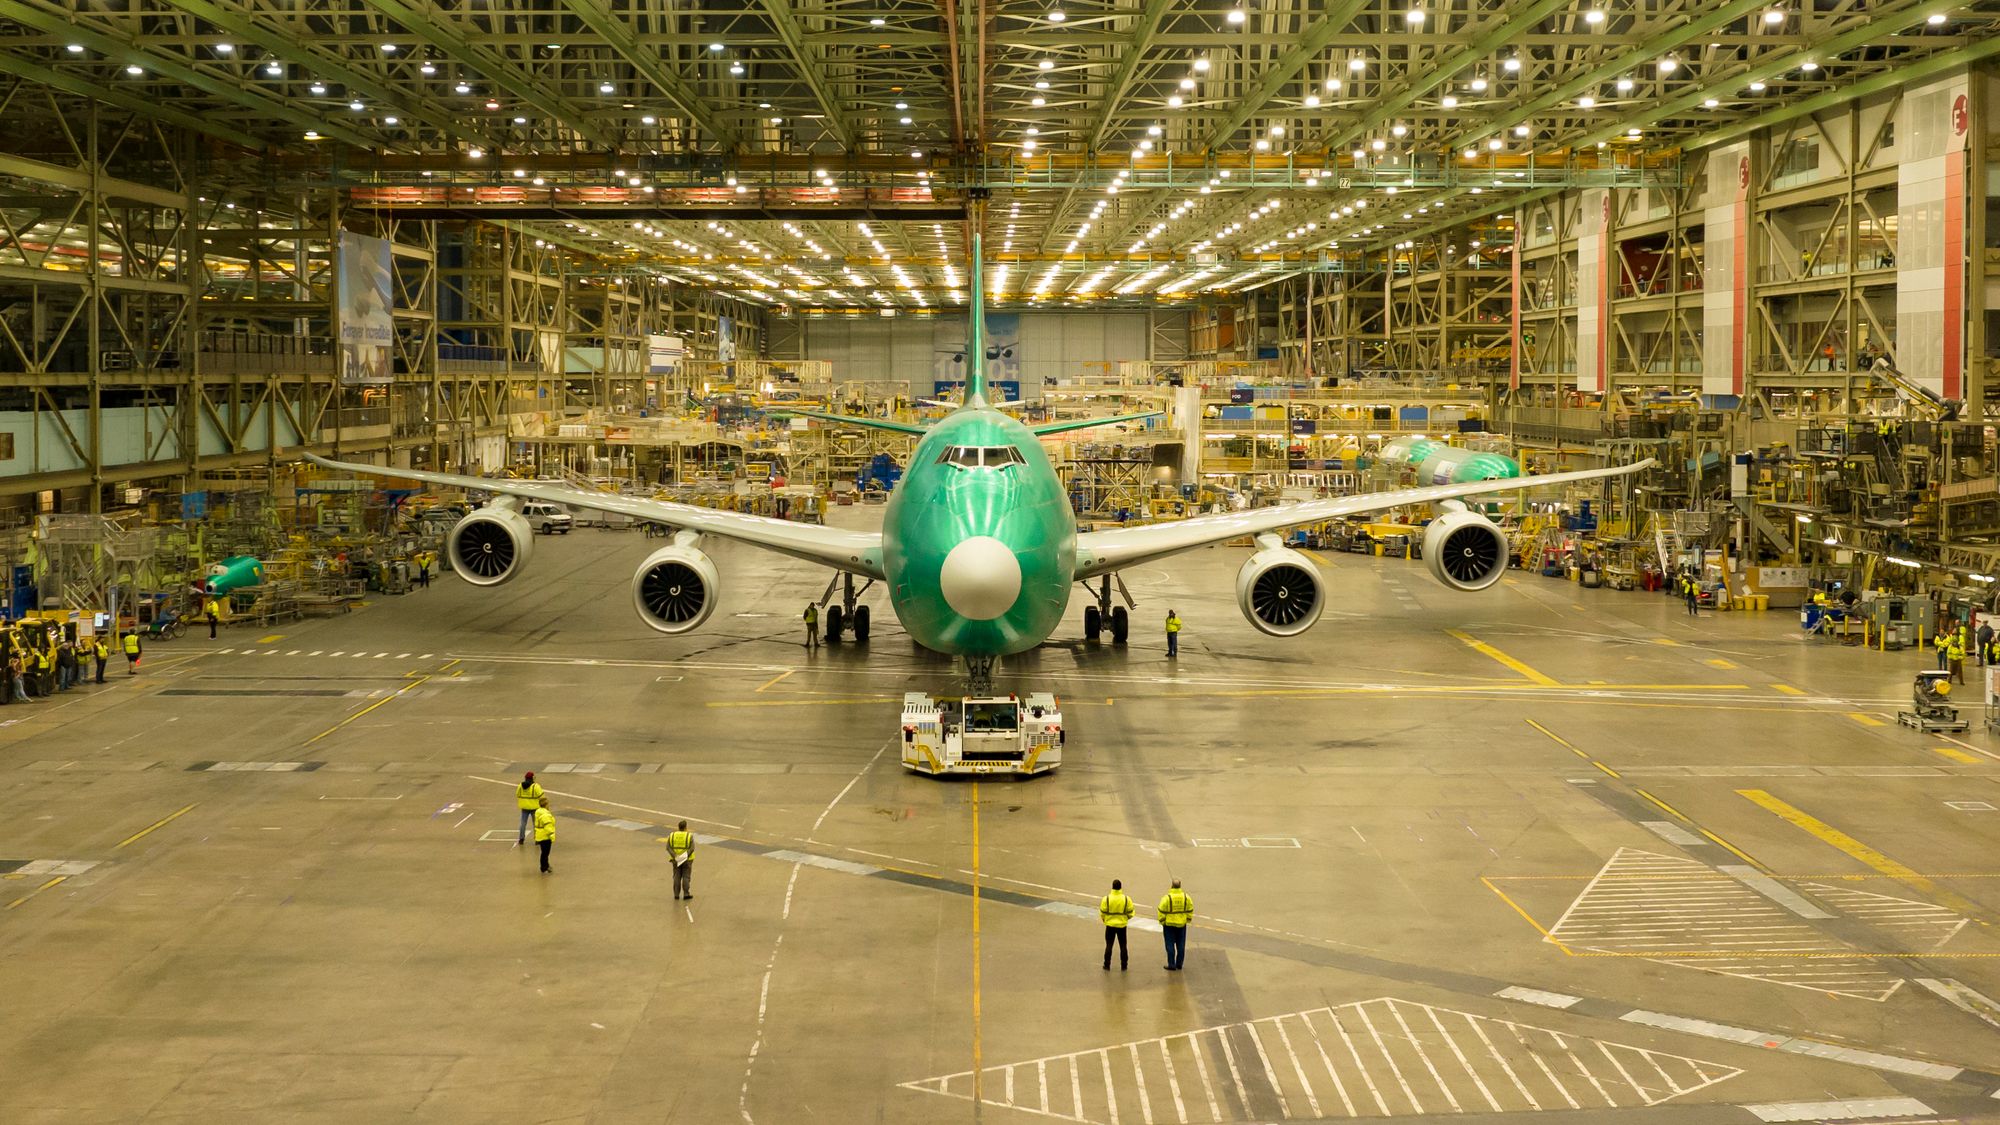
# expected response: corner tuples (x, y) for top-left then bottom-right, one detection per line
(306, 452), (884, 579)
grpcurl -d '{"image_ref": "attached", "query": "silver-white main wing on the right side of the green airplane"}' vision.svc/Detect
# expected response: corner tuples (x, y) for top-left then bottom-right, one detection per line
(1076, 458), (1654, 579)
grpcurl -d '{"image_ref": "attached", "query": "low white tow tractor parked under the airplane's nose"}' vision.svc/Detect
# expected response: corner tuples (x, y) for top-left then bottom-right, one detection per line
(902, 691), (1062, 775)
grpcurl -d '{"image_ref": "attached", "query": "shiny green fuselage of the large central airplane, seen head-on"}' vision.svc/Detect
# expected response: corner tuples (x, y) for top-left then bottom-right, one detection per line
(882, 402), (1076, 657)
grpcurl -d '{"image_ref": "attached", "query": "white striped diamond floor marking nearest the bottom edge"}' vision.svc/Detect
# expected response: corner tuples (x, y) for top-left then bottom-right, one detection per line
(902, 997), (1742, 1125)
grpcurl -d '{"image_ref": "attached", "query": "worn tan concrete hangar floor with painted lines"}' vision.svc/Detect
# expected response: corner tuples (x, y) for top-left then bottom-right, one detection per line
(0, 510), (2000, 1123)
